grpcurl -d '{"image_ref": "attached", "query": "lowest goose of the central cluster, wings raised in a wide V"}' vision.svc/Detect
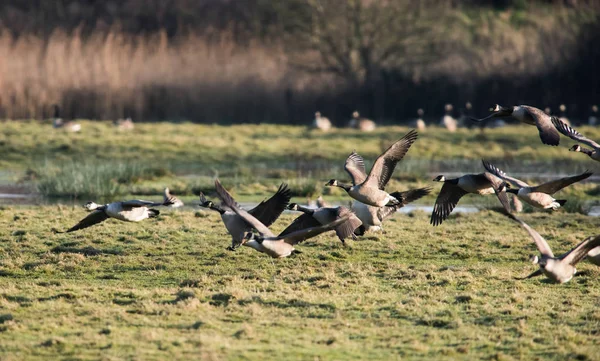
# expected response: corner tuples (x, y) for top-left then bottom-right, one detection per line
(215, 180), (350, 258)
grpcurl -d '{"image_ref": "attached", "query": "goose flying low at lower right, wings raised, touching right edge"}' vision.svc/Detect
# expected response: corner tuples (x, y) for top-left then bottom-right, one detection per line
(506, 213), (600, 283)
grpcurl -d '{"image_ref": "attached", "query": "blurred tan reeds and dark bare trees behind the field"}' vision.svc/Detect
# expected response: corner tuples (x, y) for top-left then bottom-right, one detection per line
(0, 0), (600, 125)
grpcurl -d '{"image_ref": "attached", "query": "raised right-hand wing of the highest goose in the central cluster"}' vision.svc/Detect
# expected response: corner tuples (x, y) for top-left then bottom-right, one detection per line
(365, 129), (418, 190)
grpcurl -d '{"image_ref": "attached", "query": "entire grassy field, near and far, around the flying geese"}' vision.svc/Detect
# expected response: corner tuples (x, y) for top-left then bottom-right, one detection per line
(0, 122), (600, 361)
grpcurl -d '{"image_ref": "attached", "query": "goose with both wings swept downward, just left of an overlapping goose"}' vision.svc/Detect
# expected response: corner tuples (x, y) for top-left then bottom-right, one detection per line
(429, 172), (510, 226)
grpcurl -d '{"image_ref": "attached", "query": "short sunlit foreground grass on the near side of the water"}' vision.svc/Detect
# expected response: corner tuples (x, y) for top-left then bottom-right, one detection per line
(0, 206), (600, 360)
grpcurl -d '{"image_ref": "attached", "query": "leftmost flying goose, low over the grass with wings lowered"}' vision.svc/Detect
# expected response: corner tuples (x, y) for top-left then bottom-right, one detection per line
(66, 199), (170, 233)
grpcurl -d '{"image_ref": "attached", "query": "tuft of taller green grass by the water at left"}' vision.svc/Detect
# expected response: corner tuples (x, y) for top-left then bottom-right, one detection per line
(34, 161), (164, 199)
